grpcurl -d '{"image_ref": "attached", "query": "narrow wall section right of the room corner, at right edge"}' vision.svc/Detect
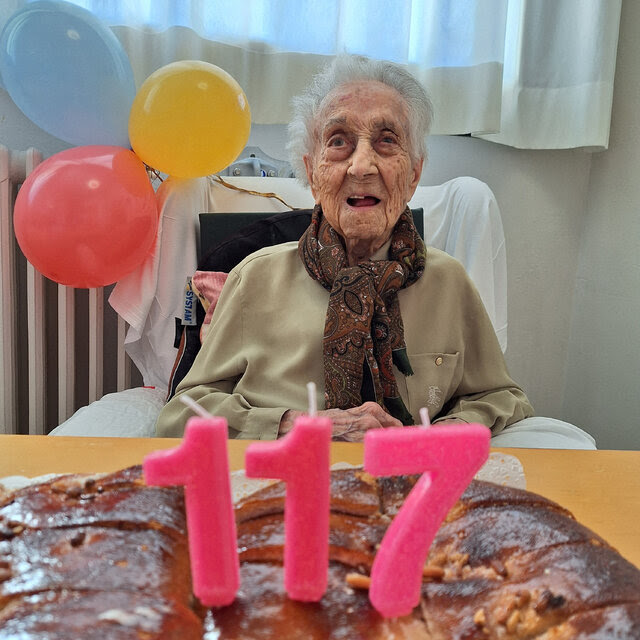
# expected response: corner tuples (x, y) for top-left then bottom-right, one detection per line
(563, 0), (640, 449)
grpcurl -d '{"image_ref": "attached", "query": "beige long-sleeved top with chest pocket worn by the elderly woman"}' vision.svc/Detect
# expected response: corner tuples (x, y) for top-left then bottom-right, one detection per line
(156, 242), (533, 439)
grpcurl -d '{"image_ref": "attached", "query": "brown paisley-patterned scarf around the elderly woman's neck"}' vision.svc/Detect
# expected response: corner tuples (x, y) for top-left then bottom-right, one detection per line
(298, 205), (426, 424)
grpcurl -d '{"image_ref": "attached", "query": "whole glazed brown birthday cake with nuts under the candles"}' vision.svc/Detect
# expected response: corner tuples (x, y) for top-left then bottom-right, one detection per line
(0, 467), (640, 640)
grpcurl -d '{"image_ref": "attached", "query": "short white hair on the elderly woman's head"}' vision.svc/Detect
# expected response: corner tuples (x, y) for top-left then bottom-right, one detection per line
(287, 55), (433, 184)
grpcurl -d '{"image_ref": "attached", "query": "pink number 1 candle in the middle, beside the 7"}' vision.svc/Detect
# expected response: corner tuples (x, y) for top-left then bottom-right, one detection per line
(245, 408), (331, 602)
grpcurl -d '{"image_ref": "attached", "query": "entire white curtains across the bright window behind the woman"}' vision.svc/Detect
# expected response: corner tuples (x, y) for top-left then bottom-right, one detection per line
(0, 0), (622, 149)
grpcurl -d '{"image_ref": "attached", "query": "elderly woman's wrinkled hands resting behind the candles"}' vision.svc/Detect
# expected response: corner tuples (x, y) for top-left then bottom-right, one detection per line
(278, 402), (402, 442)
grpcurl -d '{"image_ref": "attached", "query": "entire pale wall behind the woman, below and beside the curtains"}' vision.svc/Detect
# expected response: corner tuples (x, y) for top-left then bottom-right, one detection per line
(0, 0), (640, 449)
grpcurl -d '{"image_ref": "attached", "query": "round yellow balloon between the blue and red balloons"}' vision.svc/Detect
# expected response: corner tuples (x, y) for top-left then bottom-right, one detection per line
(129, 60), (251, 178)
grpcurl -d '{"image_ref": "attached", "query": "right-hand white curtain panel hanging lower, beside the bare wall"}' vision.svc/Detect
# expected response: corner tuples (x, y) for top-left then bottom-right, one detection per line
(483, 0), (622, 149)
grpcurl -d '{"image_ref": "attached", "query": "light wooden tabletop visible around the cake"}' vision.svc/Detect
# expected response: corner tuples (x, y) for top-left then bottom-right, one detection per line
(0, 435), (640, 567)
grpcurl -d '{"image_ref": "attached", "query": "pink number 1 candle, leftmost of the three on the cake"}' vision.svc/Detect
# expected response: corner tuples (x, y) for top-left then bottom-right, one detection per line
(143, 418), (240, 607)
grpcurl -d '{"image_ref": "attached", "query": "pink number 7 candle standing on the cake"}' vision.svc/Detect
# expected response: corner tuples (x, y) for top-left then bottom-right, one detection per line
(364, 416), (490, 617)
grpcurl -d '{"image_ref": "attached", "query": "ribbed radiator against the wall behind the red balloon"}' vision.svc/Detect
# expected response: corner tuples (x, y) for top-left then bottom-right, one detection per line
(0, 145), (140, 434)
